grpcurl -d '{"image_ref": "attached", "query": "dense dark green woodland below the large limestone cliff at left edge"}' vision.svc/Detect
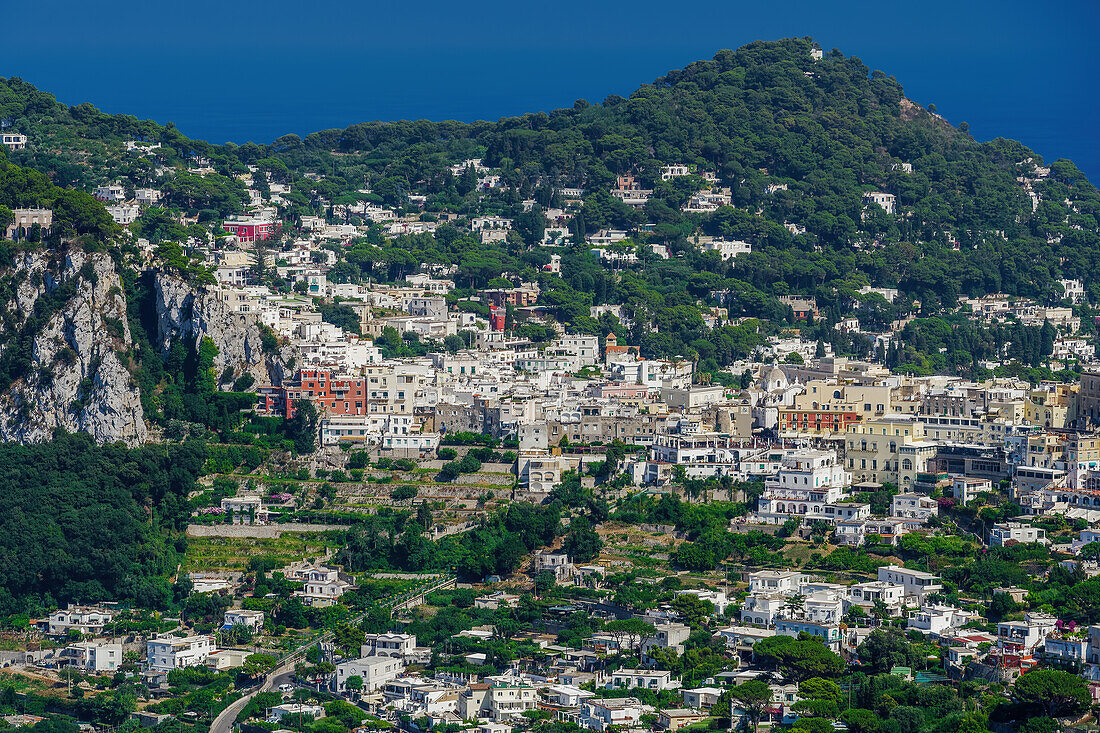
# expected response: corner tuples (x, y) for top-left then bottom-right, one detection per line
(0, 434), (206, 614)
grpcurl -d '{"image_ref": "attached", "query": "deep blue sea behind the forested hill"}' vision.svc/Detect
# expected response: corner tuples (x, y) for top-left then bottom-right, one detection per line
(0, 0), (1100, 182)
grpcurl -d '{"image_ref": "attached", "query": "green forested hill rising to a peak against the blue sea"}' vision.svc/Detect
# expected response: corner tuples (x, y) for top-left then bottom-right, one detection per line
(0, 39), (1100, 318)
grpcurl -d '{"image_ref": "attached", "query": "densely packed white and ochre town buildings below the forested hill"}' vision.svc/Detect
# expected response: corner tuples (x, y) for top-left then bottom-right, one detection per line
(180, 222), (1100, 519)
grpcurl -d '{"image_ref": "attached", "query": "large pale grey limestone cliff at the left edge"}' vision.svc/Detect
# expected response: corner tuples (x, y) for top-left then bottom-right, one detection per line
(0, 250), (147, 445)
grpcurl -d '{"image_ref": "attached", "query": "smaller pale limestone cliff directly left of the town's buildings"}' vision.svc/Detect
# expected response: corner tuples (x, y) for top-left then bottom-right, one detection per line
(155, 273), (289, 389)
